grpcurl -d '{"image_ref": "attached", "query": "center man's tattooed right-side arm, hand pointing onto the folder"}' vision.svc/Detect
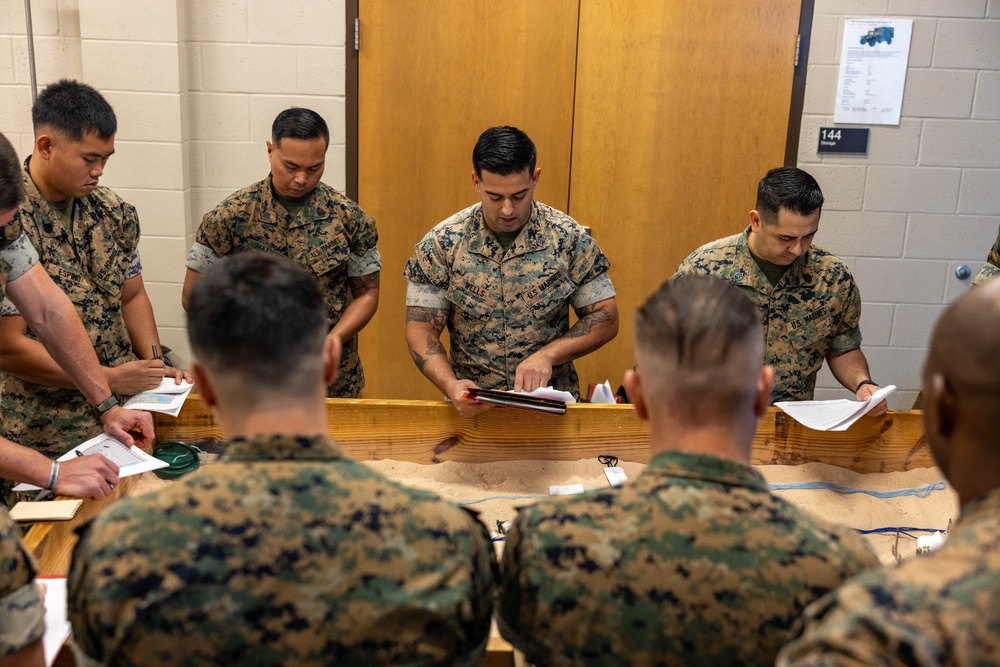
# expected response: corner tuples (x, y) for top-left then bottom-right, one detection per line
(514, 297), (618, 391)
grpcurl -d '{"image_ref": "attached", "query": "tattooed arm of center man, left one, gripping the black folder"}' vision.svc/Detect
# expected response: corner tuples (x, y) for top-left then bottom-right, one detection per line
(406, 306), (491, 417)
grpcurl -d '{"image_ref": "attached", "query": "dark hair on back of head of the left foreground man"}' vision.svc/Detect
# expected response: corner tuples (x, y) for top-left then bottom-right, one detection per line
(188, 252), (327, 395)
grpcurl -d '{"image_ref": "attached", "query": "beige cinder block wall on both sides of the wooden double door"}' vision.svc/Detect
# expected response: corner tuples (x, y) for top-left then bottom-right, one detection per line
(0, 0), (1000, 407)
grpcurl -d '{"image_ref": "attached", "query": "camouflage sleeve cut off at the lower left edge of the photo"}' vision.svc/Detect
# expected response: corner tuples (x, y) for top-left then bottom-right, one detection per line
(0, 506), (45, 657)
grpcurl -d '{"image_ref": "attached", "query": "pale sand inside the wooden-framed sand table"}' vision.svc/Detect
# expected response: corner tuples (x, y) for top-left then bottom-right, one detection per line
(364, 460), (958, 563)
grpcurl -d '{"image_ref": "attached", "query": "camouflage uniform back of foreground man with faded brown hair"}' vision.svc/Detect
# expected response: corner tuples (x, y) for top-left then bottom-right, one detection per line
(497, 451), (878, 665)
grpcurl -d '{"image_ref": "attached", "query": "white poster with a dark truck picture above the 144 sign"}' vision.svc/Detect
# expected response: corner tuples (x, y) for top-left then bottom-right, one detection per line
(833, 19), (913, 125)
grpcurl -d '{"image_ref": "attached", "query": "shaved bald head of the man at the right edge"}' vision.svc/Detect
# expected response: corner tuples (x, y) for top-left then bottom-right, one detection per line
(923, 280), (1000, 503)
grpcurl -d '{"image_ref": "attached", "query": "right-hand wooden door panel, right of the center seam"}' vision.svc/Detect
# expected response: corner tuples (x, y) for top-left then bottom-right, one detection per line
(568, 0), (800, 388)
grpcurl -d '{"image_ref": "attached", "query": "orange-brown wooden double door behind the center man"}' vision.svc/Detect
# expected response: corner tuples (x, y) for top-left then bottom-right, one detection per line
(357, 0), (801, 399)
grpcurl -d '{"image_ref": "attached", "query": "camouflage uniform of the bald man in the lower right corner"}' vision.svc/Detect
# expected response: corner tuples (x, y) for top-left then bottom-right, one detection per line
(779, 489), (1000, 665)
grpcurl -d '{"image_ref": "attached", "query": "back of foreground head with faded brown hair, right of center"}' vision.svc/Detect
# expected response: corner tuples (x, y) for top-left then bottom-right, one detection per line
(635, 275), (764, 428)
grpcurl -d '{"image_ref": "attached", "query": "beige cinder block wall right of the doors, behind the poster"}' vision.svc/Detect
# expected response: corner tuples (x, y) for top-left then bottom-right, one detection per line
(798, 0), (1000, 409)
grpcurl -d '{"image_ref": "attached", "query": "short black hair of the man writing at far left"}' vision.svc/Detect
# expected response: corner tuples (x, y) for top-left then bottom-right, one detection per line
(31, 79), (118, 141)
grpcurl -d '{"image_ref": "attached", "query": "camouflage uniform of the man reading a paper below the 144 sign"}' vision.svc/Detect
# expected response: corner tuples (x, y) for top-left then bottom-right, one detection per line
(676, 227), (861, 403)
